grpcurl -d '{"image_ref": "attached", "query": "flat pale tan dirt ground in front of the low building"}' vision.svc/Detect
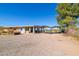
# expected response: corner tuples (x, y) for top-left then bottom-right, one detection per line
(0, 33), (79, 56)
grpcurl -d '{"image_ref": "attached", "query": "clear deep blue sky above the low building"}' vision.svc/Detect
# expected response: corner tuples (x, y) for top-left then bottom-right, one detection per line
(0, 3), (57, 26)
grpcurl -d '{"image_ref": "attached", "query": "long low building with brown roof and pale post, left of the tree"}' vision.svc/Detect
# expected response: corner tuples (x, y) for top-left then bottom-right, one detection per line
(0, 26), (47, 34)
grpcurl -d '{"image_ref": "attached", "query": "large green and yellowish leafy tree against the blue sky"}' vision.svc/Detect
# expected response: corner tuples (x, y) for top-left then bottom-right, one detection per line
(56, 3), (79, 32)
